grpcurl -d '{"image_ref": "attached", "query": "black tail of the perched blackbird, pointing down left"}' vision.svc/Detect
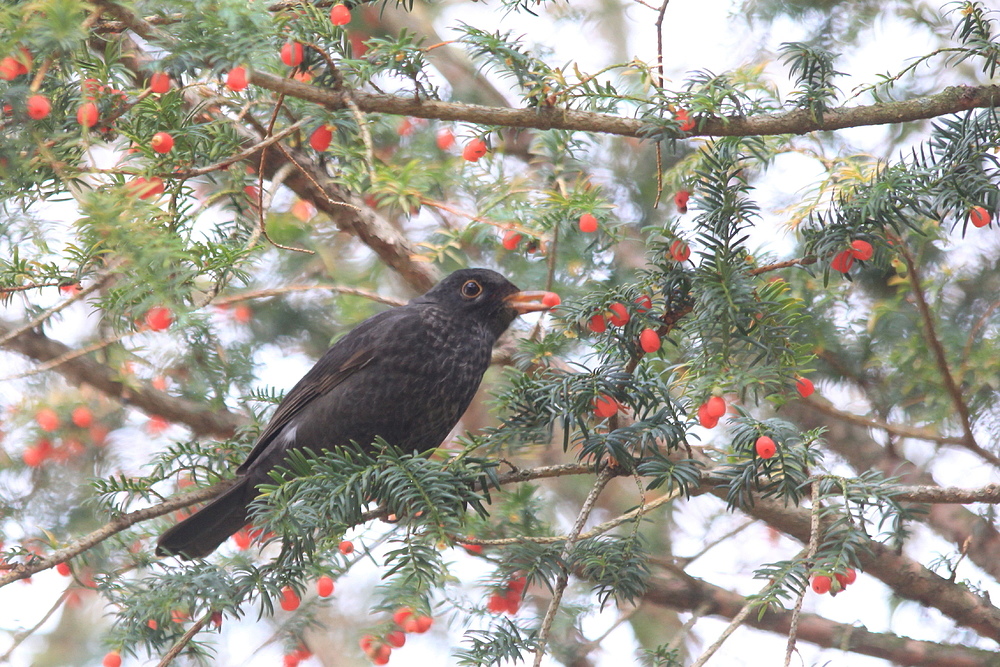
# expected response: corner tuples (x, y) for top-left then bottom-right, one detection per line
(156, 477), (253, 559)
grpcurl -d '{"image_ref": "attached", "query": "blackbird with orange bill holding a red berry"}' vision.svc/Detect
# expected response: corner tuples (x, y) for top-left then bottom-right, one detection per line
(156, 269), (548, 559)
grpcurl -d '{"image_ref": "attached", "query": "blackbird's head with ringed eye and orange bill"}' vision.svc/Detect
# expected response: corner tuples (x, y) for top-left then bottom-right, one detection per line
(414, 269), (551, 337)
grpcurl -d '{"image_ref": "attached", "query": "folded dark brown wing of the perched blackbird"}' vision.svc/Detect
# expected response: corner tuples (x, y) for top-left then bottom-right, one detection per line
(236, 306), (408, 475)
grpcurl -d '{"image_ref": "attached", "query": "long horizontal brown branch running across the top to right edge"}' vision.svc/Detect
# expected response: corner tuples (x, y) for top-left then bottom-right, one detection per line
(249, 70), (1000, 137)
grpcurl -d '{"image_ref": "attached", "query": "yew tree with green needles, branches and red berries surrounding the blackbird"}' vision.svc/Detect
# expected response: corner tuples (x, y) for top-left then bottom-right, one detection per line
(0, 0), (1000, 665)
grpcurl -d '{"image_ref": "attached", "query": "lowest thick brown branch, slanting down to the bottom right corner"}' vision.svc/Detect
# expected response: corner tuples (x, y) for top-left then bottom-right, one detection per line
(643, 576), (997, 667)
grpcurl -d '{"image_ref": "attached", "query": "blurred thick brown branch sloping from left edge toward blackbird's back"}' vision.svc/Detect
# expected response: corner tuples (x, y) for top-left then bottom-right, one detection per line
(0, 322), (245, 438)
